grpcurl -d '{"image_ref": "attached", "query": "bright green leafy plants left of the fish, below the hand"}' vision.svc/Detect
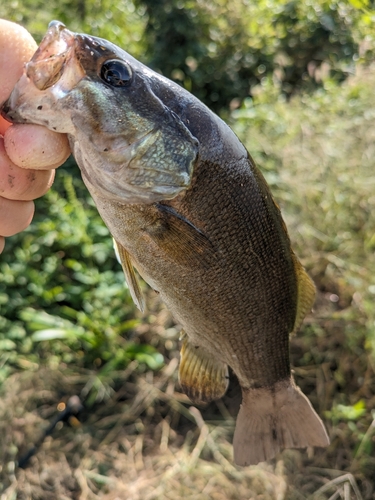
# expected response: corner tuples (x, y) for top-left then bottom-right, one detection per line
(0, 167), (162, 381)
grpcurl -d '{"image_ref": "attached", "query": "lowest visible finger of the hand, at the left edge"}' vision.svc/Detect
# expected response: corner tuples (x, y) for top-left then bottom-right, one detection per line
(0, 196), (34, 236)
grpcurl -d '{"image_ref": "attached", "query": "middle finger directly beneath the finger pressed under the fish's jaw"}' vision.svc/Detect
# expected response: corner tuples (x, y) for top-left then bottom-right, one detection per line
(0, 138), (55, 200)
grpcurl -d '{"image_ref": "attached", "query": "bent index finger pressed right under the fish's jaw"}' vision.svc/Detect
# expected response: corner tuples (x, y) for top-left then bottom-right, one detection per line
(4, 124), (70, 170)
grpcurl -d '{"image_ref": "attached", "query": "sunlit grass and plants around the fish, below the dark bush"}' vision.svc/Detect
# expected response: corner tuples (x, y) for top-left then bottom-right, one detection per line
(0, 67), (375, 500)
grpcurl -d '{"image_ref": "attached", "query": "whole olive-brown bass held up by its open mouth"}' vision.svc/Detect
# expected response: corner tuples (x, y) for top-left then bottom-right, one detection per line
(2, 21), (329, 466)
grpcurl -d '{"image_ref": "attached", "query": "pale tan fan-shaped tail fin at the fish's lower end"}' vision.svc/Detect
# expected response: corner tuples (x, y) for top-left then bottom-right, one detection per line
(233, 380), (329, 466)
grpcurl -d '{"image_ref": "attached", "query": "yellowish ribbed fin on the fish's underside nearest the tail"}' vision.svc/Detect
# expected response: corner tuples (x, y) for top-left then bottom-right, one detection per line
(178, 333), (229, 403)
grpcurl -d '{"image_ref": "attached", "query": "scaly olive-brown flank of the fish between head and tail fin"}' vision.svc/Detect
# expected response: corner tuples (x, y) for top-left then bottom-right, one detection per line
(96, 150), (297, 388)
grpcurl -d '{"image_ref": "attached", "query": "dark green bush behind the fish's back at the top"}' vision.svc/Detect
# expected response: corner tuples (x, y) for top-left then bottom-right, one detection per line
(138, 0), (374, 112)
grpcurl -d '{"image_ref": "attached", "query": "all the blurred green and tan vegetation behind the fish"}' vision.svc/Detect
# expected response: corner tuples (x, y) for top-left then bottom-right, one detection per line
(0, 0), (375, 500)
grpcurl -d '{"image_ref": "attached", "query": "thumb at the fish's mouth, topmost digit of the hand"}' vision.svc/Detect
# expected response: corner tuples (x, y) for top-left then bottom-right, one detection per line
(0, 19), (37, 103)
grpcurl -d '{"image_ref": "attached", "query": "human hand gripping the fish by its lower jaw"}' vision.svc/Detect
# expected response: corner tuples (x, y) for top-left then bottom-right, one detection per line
(0, 19), (70, 253)
